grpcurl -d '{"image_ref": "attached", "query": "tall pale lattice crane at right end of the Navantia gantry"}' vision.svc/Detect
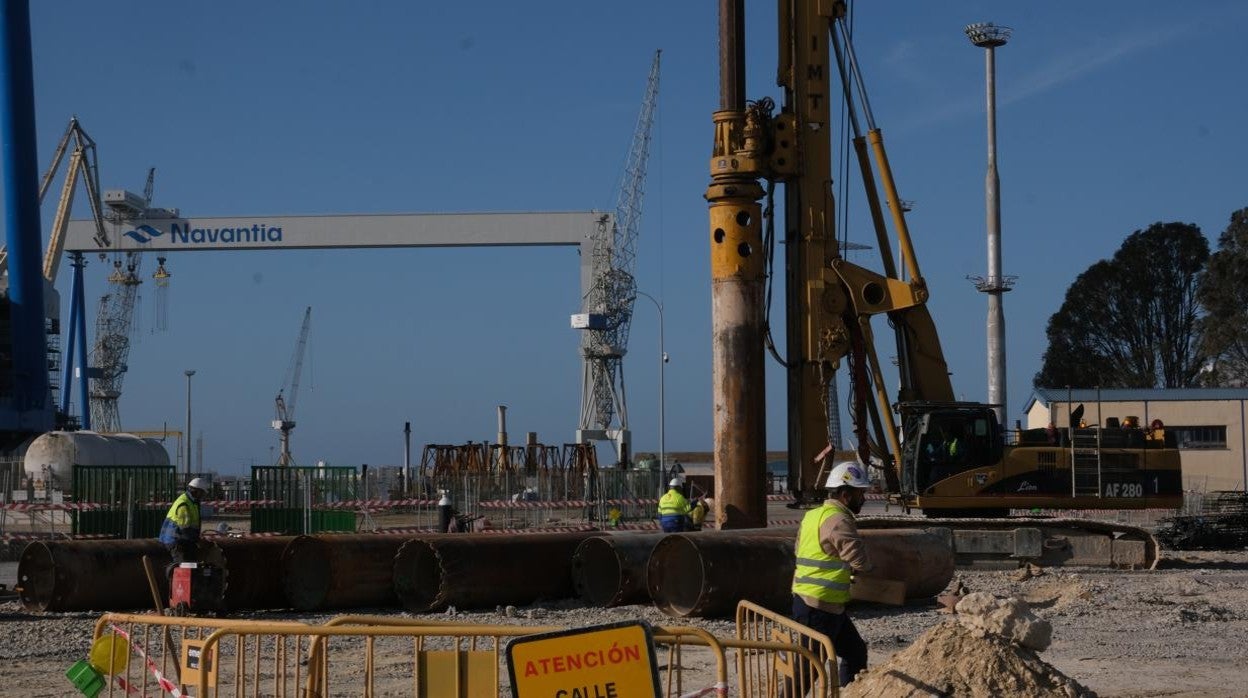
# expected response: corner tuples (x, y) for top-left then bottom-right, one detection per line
(577, 51), (663, 463)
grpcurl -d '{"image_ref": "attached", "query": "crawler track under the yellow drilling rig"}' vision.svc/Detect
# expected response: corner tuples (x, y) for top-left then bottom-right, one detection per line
(857, 517), (1161, 569)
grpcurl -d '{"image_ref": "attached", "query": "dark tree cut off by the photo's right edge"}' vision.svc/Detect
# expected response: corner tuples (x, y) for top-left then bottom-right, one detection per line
(1198, 209), (1248, 387)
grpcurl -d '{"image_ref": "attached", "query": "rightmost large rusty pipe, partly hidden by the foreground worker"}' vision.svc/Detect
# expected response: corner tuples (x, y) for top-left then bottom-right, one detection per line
(646, 528), (953, 617)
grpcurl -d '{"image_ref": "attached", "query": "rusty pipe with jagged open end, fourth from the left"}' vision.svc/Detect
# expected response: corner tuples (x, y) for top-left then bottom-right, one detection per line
(394, 531), (597, 612)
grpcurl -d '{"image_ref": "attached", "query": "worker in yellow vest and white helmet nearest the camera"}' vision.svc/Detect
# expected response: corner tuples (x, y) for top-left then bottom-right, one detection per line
(792, 461), (872, 689)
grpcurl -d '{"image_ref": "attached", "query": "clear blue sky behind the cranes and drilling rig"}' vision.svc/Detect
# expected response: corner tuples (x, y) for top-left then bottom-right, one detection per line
(12, 0), (1248, 472)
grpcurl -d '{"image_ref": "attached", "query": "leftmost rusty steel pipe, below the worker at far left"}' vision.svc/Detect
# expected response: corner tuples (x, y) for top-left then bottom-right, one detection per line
(17, 539), (170, 611)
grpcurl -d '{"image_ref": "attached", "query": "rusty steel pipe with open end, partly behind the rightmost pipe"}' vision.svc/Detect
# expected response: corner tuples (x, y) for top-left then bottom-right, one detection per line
(572, 527), (797, 608)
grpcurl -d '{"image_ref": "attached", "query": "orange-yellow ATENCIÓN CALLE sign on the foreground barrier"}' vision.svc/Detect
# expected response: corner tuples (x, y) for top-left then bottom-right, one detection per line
(507, 621), (660, 698)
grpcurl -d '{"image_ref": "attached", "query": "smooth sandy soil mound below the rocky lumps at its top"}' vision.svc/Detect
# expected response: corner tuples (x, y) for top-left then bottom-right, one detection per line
(841, 621), (1096, 698)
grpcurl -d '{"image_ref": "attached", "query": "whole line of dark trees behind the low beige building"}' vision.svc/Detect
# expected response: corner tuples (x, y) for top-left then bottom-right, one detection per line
(1033, 209), (1248, 388)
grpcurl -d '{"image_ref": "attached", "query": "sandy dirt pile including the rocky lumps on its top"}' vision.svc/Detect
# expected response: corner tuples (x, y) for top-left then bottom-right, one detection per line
(841, 593), (1096, 698)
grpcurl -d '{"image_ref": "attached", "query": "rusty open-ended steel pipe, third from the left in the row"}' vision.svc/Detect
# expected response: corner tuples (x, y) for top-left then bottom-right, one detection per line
(282, 533), (419, 611)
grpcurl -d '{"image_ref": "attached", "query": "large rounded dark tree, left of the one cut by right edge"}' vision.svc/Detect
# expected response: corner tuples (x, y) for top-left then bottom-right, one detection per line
(1035, 224), (1209, 388)
